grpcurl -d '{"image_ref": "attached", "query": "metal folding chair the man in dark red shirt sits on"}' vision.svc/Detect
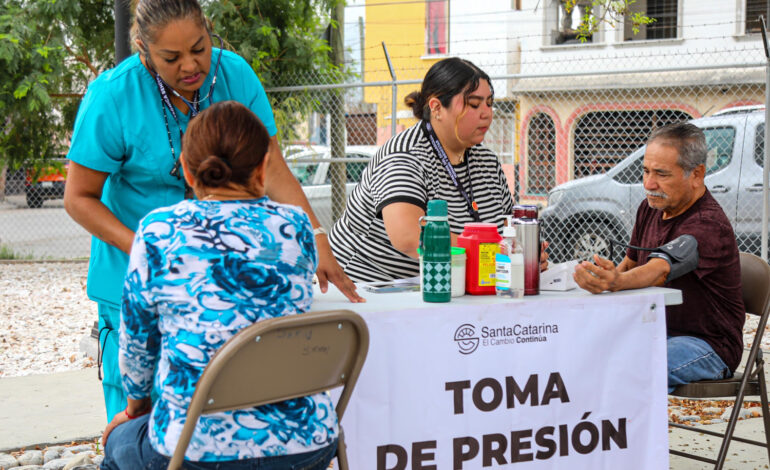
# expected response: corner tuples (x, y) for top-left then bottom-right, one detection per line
(668, 253), (770, 470)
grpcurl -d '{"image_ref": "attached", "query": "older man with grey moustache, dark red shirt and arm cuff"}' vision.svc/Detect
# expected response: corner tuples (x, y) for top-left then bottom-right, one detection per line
(574, 123), (745, 392)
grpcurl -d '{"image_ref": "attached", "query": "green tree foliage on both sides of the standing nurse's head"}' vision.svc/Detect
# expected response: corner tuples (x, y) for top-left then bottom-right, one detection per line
(0, 0), (344, 168)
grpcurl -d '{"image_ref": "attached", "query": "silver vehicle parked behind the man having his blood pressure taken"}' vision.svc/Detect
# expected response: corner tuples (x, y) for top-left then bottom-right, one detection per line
(540, 107), (765, 262)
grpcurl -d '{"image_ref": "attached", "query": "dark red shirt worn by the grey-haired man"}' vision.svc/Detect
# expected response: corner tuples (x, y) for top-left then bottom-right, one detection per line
(626, 189), (746, 371)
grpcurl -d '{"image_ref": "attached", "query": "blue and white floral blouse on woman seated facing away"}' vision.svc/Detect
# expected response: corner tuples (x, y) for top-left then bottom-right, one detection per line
(120, 197), (338, 462)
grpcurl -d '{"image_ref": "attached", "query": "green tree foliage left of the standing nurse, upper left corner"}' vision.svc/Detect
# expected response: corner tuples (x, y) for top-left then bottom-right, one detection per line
(0, 0), (114, 173)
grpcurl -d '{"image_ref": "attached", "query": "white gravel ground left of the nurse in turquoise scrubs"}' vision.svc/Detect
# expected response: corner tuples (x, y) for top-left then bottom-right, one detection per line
(0, 262), (97, 377)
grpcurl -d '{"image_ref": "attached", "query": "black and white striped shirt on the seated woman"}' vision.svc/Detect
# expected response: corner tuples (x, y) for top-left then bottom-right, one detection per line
(329, 123), (513, 281)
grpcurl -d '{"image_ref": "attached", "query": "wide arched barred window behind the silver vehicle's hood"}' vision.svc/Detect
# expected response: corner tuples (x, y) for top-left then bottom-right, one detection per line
(574, 109), (692, 178)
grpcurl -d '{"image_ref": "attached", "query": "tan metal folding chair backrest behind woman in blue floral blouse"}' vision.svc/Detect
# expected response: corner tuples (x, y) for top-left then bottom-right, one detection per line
(169, 310), (369, 468)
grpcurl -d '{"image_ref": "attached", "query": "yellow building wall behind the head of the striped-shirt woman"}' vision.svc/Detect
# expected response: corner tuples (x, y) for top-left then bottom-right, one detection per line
(364, 0), (440, 144)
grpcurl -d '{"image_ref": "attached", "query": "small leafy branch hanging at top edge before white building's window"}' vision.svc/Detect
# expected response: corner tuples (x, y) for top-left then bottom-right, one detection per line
(561, 0), (655, 42)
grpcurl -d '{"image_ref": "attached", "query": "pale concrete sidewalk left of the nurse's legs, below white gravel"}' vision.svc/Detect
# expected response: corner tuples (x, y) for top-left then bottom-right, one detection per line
(0, 368), (107, 452)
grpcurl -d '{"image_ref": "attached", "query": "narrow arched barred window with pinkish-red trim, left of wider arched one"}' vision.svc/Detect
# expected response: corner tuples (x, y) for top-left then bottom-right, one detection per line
(527, 113), (556, 196)
